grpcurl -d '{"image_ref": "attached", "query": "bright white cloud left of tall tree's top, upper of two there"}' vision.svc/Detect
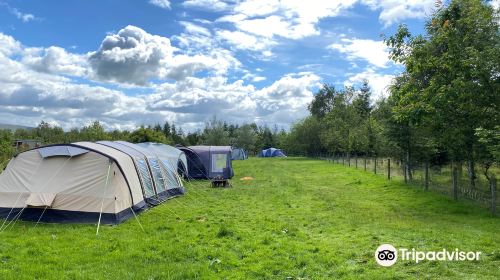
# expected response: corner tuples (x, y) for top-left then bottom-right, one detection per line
(327, 38), (391, 68)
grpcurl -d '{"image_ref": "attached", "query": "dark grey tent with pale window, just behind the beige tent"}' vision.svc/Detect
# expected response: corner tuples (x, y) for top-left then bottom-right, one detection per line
(177, 146), (234, 179)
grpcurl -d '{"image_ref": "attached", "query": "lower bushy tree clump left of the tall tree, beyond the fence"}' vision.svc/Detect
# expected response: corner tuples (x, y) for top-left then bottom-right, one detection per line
(296, 81), (381, 155)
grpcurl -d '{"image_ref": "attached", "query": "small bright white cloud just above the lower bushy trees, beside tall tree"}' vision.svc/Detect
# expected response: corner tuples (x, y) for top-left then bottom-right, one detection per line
(345, 68), (395, 100)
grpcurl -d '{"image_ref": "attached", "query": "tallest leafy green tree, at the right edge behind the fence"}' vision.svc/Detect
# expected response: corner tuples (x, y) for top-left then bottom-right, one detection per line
(387, 0), (500, 188)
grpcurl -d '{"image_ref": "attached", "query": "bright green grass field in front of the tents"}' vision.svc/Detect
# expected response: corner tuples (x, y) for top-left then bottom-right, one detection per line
(0, 158), (500, 279)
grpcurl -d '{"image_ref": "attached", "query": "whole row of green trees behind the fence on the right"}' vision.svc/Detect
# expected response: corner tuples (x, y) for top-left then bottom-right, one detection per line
(287, 0), (500, 188)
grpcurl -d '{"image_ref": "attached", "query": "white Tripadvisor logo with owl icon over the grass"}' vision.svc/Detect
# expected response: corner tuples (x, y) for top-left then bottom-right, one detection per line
(375, 244), (481, 266)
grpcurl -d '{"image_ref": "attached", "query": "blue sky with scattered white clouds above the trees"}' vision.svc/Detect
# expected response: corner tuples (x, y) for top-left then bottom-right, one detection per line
(0, 0), (435, 131)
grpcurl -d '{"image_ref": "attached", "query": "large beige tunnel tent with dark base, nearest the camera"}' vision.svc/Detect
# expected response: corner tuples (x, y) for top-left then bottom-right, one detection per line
(0, 142), (184, 224)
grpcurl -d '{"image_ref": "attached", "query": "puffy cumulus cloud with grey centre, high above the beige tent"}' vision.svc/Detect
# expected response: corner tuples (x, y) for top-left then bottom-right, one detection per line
(89, 26), (241, 86)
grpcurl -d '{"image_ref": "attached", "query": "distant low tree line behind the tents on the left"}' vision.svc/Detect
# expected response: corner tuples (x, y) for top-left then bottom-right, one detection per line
(0, 116), (287, 165)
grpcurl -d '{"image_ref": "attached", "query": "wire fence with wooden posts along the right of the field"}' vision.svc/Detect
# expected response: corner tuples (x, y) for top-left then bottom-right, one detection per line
(320, 156), (500, 215)
